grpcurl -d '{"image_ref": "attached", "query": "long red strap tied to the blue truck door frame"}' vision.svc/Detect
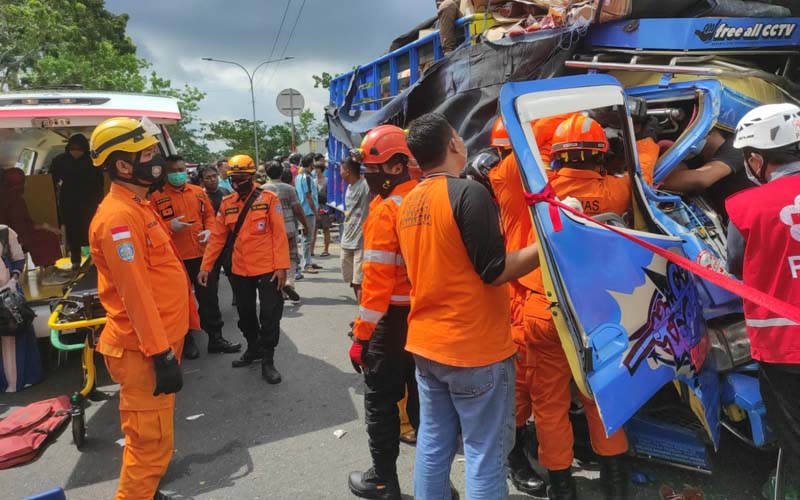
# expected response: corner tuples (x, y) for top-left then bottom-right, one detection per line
(525, 188), (800, 324)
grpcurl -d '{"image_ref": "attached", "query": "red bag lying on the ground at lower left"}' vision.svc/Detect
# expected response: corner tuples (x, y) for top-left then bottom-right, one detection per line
(0, 396), (70, 469)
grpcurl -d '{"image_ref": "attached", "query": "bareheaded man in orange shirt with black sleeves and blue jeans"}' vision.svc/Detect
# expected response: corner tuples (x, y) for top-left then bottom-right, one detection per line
(397, 113), (539, 500)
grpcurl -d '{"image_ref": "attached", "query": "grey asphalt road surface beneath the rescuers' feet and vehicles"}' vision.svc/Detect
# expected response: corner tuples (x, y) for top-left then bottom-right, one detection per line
(0, 247), (774, 500)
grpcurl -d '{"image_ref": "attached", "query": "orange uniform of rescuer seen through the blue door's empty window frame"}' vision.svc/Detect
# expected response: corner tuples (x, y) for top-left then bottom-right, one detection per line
(524, 139), (659, 470)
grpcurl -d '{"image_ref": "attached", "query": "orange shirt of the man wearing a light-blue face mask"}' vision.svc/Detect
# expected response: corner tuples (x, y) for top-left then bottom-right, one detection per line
(150, 183), (216, 260)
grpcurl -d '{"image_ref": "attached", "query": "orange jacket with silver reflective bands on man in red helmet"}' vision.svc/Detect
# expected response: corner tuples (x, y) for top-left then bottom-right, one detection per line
(353, 180), (417, 340)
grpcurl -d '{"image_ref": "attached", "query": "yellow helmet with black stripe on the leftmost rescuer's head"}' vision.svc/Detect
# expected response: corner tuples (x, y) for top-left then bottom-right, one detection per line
(89, 117), (161, 167)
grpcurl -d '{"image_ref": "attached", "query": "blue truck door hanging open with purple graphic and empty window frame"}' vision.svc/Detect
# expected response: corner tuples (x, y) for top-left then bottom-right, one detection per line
(500, 75), (719, 442)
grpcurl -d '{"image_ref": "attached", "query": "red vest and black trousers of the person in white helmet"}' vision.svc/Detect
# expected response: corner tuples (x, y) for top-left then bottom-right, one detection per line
(726, 170), (800, 466)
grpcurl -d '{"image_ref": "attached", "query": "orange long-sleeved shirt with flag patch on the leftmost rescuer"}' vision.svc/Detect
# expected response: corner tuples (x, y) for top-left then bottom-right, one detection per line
(89, 184), (194, 356)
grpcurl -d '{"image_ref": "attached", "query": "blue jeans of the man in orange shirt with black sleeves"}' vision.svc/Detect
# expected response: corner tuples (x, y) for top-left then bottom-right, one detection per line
(414, 355), (515, 500)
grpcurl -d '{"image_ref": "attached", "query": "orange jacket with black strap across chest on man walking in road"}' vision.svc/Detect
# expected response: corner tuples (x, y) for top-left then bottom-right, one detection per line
(200, 186), (291, 276)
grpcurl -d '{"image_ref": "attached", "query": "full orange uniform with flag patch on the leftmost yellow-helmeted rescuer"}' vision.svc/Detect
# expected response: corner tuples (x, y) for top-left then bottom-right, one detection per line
(89, 184), (196, 500)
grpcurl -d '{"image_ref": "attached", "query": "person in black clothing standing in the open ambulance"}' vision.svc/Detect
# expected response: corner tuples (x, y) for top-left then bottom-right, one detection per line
(50, 134), (103, 270)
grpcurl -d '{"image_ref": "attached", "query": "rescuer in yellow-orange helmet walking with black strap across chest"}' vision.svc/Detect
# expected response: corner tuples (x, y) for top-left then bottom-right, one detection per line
(197, 155), (290, 384)
